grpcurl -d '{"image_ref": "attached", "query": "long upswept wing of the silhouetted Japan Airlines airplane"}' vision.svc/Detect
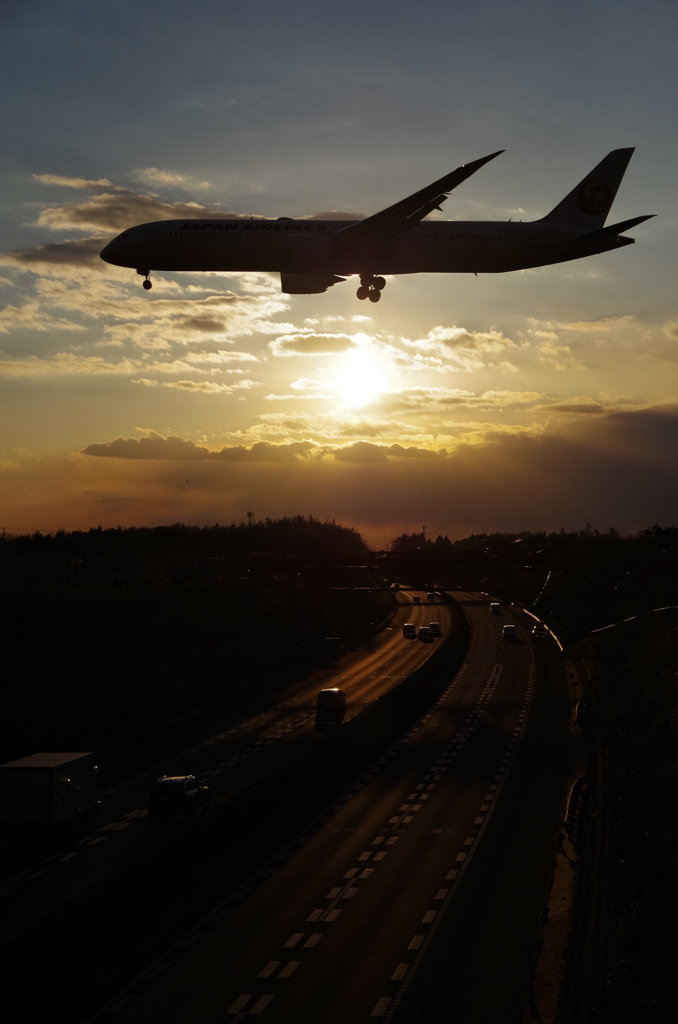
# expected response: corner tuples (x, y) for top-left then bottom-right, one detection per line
(337, 150), (504, 244)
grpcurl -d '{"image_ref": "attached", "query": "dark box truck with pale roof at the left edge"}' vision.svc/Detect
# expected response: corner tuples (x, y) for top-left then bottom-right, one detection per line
(0, 752), (101, 834)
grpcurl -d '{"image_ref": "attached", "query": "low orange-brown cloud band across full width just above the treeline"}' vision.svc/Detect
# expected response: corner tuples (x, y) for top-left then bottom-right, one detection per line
(0, 404), (678, 546)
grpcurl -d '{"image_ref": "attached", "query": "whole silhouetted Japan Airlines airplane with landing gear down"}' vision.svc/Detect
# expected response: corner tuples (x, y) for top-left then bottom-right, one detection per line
(101, 147), (654, 302)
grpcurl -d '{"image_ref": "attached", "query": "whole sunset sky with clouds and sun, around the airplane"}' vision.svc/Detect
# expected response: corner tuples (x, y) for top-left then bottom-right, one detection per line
(0, 0), (678, 547)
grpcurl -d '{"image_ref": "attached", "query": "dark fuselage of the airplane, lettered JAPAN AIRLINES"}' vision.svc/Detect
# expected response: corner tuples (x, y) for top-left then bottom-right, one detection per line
(103, 218), (633, 276)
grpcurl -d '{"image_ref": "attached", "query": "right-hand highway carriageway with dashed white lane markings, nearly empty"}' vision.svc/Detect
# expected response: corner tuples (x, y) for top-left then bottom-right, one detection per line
(85, 594), (567, 1024)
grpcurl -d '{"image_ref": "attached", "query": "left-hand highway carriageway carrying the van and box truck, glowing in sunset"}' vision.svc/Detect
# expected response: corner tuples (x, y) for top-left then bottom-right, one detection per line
(0, 591), (450, 943)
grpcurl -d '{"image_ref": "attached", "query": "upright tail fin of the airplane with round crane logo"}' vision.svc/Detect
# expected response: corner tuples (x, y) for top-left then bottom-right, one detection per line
(540, 146), (635, 232)
